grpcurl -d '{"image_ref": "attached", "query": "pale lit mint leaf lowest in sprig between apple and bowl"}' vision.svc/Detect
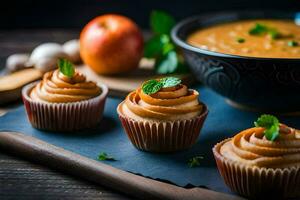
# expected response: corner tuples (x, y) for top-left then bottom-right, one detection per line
(155, 51), (179, 74)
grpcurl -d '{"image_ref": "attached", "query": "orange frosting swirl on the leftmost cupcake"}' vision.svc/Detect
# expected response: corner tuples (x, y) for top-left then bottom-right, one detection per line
(30, 70), (101, 103)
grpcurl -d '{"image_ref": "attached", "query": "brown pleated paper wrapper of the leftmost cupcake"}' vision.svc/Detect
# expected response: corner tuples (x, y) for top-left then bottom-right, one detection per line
(22, 82), (108, 131)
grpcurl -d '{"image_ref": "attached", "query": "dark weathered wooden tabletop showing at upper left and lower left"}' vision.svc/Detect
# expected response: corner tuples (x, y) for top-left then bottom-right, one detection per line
(0, 30), (132, 200)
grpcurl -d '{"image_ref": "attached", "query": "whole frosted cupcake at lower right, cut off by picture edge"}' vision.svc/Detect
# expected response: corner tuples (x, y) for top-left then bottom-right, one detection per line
(213, 115), (300, 199)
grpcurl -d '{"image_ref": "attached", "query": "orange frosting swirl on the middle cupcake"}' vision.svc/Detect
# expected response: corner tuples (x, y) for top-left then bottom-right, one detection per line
(119, 84), (202, 121)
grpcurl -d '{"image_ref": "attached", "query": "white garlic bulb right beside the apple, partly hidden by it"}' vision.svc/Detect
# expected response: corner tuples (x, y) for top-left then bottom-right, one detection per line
(62, 39), (81, 63)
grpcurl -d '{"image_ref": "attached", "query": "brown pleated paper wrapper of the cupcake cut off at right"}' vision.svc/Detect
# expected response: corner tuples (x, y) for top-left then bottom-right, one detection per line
(213, 139), (300, 199)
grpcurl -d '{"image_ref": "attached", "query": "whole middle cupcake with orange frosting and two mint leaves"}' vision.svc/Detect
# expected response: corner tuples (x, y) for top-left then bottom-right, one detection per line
(117, 77), (208, 152)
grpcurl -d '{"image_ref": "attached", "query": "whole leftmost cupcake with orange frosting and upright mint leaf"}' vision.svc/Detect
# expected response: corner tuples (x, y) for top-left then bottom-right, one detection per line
(22, 59), (108, 131)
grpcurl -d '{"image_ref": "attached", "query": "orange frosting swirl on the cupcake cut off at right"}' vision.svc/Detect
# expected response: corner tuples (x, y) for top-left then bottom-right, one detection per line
(220, 124), (300, 168)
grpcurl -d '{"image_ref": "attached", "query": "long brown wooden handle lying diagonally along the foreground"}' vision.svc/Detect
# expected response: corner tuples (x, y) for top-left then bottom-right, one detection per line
(0, 132), (242, 200)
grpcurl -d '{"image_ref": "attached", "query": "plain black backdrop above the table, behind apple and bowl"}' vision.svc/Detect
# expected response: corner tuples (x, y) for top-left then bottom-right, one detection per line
(0, 0), (300, 29)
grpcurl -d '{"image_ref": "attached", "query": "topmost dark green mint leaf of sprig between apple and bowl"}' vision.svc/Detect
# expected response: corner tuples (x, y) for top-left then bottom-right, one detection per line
(150, 10), (176, 34)
